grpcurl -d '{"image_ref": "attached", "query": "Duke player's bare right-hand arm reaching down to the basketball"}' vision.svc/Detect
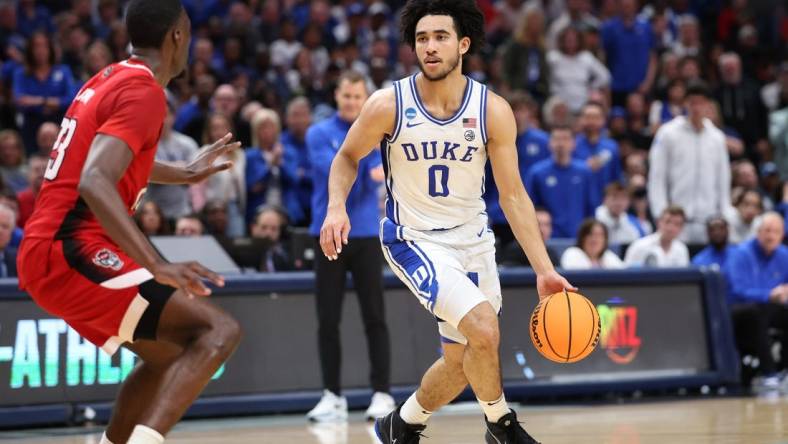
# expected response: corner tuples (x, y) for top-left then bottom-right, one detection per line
(487, 93), (576, 297)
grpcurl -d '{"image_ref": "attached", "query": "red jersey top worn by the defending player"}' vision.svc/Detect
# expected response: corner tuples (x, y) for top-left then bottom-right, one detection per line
(25, 60), (167, 241)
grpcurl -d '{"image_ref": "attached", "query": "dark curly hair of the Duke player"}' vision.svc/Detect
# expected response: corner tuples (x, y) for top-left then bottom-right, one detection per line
(400, 0), (484, 53)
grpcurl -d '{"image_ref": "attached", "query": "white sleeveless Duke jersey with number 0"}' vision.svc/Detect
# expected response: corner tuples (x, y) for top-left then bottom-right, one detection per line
(381, 75), (487, 230)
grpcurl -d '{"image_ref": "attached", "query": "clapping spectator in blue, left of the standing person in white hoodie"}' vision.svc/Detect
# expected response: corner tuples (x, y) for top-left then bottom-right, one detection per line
(573, 102), (622, 207)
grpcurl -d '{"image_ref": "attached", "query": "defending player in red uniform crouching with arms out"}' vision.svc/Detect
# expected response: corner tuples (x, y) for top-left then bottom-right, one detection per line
(18, 0), (240, 444)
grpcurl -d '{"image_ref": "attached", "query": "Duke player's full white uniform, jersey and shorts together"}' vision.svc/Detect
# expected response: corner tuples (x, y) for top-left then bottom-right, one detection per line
(380, 76), (501, 344)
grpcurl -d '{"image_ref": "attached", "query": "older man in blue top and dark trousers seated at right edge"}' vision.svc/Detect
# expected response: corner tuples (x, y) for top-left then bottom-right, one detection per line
(725, 212), (788, 389)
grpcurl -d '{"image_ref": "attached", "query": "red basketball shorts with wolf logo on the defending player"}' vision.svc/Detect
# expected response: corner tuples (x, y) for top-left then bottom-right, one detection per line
(17, 238), (175, 355)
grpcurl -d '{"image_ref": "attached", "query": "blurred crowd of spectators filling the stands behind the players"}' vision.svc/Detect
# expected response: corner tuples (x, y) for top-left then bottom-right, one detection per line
(0, 0), (788, 275)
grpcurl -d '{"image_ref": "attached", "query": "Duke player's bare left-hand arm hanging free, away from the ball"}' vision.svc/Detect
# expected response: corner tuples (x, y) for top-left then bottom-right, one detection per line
(320, 88), (397, 260)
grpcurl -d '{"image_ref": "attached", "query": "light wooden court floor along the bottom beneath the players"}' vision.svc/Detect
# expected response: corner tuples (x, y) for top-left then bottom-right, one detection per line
(0, 396), (788, 444)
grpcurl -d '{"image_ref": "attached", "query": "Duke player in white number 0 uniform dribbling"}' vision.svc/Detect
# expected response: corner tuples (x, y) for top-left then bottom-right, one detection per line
(320, 0), (575, 444)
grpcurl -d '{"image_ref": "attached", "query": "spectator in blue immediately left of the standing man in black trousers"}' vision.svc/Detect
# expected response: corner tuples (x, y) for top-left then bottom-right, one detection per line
(280, 97), (312, 226)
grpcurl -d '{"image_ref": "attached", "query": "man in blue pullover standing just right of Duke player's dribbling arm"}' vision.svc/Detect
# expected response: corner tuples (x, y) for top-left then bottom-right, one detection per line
(525, 125), (599, 238)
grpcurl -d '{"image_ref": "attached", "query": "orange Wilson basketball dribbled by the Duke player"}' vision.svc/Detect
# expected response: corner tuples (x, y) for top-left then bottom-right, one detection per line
(531, 291), (601, 363)
